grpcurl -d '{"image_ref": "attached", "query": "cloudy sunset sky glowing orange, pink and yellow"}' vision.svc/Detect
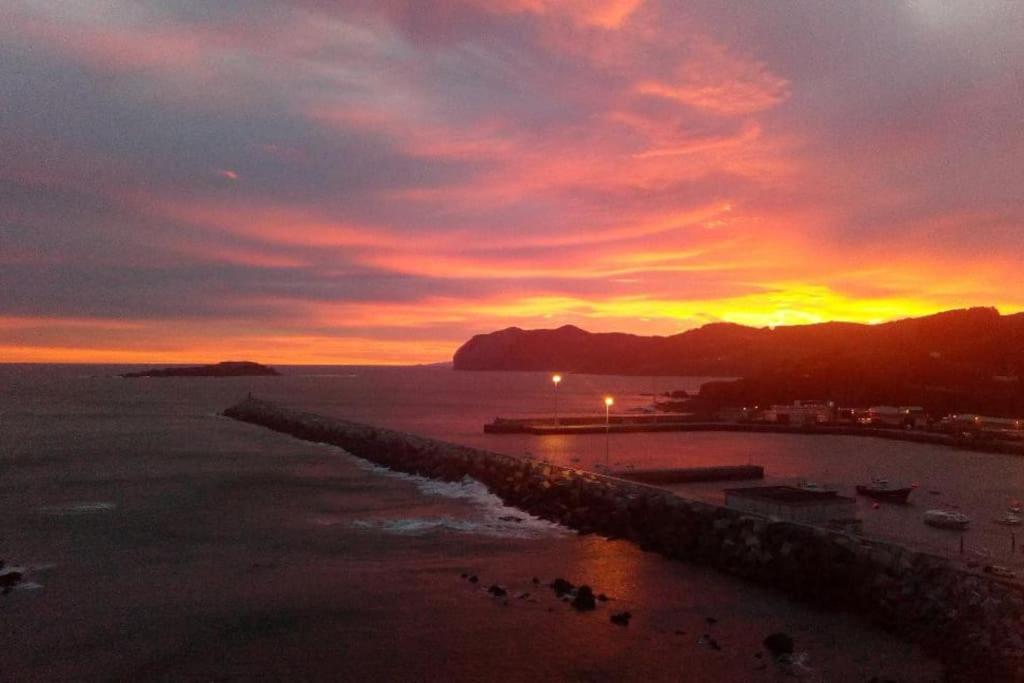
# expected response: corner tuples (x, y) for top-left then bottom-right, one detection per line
(0, 0), (1024, 364)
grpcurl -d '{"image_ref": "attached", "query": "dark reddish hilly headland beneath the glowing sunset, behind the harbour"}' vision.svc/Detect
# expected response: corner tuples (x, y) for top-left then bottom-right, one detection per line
(454, 308), (1024, 416)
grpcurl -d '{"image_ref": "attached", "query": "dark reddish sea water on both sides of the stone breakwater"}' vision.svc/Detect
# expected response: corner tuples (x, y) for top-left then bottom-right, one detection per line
(0, 365), (958, 681)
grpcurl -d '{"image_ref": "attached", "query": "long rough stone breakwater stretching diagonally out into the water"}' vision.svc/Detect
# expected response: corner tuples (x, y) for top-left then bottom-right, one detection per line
(224, 398), (1024, 681)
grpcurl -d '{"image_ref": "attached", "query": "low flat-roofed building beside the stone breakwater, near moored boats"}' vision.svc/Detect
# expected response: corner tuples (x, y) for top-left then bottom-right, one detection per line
(725, 486), (857, 525)
